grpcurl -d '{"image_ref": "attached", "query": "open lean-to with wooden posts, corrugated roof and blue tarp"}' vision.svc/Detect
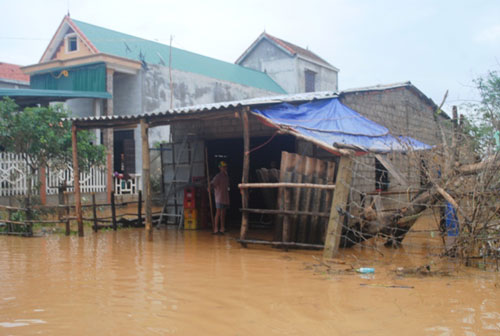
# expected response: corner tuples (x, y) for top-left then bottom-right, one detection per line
(73, 92), (436, 256)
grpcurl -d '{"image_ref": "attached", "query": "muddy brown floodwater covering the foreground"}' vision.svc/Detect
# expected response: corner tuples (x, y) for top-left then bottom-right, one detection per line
(0, 215), (500, 336)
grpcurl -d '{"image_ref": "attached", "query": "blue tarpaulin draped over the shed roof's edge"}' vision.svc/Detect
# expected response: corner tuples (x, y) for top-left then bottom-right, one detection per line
(252, 98), (431, 153)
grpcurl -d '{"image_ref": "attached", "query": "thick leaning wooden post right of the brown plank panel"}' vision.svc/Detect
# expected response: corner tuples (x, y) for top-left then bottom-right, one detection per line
(323, 156), (353, 258)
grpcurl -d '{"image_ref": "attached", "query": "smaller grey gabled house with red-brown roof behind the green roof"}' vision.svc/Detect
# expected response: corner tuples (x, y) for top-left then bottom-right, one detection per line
(236, 32), (339, 94)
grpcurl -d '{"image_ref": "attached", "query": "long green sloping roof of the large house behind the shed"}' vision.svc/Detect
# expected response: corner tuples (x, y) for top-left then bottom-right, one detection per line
(71, 19), (286, 93)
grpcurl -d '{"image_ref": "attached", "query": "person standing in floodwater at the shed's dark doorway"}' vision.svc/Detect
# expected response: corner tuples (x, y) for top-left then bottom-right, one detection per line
(210, 161), (229, 234)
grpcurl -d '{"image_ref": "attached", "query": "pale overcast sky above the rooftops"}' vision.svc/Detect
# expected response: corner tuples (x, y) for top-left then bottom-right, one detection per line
(0, 0), (500, 111)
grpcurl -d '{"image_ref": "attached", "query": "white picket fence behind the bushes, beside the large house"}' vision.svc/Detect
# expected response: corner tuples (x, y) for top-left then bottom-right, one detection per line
(0, 152), (141, 197)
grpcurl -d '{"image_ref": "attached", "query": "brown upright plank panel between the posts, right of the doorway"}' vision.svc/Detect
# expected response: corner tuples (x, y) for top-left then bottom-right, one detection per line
(274, 152), (335, 244)
